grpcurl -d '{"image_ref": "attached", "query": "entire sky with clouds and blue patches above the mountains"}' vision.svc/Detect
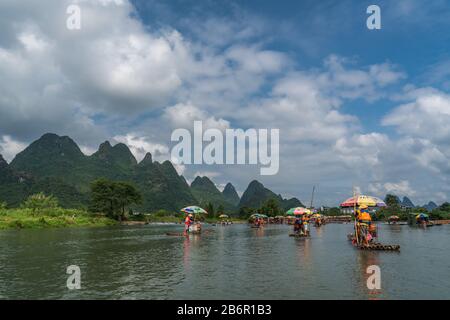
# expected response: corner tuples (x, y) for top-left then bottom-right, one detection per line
(0, 0), (450, 206)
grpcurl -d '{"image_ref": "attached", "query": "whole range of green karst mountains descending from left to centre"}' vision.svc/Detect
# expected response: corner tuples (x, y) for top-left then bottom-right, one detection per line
(0, 133), (302, 214)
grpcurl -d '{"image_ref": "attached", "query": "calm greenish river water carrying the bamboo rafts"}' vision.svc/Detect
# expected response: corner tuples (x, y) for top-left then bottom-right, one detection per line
(0, 224), (450, 299)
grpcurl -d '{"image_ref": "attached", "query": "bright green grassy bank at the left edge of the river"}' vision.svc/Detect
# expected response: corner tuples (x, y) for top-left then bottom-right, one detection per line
(0, 208), (117, 230)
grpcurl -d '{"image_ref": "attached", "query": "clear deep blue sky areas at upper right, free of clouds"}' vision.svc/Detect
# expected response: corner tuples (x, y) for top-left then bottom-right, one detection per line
(128, 0), (450, 131)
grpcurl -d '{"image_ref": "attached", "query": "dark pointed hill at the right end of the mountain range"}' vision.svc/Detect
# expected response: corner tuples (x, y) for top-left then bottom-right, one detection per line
(239, 180), (303, 210)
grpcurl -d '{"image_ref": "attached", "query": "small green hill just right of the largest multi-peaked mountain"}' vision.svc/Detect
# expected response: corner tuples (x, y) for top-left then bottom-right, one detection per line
(191, 177), (236, 213)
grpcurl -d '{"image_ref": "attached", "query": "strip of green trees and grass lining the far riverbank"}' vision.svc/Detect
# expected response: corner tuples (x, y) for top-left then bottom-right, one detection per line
(0, 178), (450, 230)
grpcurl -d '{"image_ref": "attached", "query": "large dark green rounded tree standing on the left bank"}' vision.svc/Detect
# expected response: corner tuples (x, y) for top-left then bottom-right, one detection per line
(90, 179), (142, 221)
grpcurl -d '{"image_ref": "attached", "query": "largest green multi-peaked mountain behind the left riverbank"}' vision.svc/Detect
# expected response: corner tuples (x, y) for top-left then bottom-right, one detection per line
(4, 133), (197, 211)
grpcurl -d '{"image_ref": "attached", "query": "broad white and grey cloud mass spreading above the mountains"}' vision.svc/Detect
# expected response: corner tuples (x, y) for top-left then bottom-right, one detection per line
(0, 0), (450, 204)
